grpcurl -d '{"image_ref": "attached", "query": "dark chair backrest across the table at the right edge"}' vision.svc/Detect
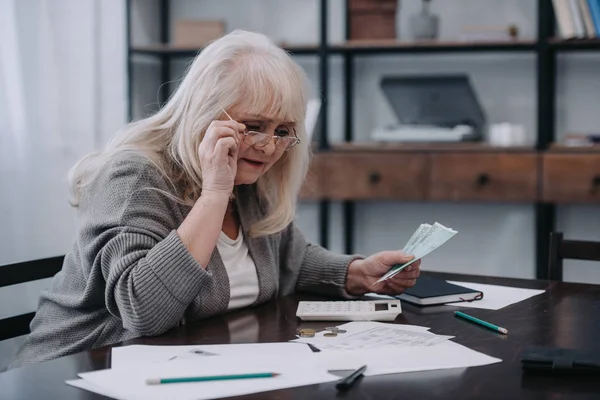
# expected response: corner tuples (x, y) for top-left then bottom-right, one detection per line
(548, 232), (600, 281)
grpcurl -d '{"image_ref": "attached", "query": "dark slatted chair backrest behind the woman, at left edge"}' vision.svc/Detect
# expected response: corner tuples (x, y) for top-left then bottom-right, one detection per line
(0, 256), (65, 341)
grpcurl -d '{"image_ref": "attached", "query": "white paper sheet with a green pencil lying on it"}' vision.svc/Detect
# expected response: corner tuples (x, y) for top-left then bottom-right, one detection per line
(79, 356), (339, 400)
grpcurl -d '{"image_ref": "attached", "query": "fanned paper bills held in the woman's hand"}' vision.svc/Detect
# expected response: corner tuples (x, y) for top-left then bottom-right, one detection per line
(375, 222), (457, 283)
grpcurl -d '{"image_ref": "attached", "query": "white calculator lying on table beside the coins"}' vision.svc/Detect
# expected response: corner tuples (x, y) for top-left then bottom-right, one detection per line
(296, 300), (402, 321)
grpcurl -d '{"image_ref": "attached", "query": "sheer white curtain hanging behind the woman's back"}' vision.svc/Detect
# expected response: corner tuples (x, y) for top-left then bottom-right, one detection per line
(0, 0), (127, 265)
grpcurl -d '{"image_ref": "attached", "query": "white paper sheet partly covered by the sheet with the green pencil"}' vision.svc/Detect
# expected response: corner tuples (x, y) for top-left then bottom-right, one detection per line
(111, 342), (312, 369)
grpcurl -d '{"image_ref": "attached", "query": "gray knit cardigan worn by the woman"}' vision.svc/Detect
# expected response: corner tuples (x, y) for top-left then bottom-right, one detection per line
(11, 153), (356, 368)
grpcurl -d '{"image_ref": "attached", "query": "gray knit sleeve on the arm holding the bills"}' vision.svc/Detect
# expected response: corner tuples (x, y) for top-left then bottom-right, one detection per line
(280, 223), (363, 298)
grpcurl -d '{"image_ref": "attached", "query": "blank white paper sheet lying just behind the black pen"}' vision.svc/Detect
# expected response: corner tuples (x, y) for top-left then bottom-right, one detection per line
(313, 341), (502, 376)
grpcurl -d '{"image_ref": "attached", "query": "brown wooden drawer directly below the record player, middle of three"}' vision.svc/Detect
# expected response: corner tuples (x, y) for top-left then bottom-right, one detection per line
(431, 153), (538, 202)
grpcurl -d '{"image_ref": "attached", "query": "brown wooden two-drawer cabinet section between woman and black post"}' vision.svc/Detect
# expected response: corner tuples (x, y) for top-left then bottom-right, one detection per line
(302, 150), (540, 202)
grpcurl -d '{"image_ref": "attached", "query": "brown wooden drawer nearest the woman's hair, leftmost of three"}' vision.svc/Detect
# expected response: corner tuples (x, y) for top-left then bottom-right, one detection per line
(302, 152), (427, 200)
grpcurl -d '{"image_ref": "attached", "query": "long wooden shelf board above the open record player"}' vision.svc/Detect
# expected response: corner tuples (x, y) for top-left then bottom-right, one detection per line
(331, 40), (535, 54)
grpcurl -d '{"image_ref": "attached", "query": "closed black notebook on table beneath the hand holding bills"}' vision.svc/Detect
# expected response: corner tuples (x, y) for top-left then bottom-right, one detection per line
(396, 275), (483, 306)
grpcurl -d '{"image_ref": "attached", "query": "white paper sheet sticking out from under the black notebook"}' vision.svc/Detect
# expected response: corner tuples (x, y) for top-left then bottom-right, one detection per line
(448, 281), (544, 310)
